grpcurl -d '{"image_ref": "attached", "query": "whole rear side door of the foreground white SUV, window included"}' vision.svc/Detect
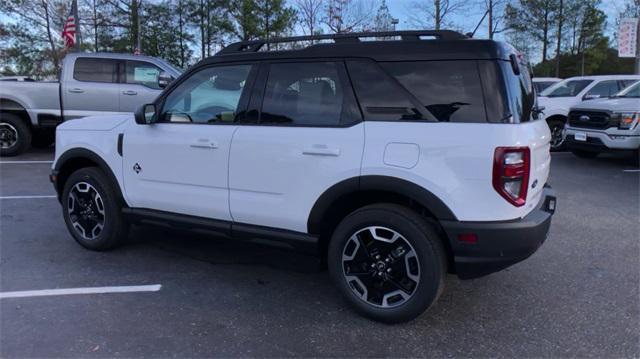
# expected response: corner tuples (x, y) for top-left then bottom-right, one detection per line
(229, 61), (364, 232)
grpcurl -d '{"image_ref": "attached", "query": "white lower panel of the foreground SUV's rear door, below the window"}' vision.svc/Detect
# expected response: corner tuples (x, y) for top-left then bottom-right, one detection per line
(229, 123), (364, 232)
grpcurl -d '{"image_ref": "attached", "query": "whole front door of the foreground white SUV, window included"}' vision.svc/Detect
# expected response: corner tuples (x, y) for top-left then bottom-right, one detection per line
(123, 64), (252, 221)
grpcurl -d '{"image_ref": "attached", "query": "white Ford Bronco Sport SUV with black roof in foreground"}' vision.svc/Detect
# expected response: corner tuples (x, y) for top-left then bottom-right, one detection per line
(51, 31), (555, 322)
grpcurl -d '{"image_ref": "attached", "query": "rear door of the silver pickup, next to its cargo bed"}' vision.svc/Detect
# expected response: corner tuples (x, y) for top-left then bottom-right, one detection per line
(62, 57), (120, 120)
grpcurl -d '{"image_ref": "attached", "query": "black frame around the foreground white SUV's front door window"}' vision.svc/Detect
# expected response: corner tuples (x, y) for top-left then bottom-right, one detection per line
(152, 61), (260, 126)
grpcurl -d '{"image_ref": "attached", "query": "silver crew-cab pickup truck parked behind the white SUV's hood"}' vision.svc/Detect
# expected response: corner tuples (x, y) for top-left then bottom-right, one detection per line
(0, 53), (181, 156)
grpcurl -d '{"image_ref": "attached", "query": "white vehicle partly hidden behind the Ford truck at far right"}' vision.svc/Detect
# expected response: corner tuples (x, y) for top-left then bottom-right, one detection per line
(538, 75), (640, 150)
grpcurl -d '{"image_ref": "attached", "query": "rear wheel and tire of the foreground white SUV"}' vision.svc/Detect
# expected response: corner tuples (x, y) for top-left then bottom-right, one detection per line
(327, 204), (447, 323)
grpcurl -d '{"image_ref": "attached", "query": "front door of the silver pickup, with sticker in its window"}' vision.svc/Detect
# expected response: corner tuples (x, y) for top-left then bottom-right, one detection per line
(119, 60), (162, 112)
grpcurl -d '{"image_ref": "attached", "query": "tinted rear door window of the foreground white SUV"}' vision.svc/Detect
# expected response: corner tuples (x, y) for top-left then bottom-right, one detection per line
(260, 62), (344, 126)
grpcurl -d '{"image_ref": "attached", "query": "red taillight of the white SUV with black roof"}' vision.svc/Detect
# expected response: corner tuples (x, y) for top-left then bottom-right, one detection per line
(493, 147), (531, 207)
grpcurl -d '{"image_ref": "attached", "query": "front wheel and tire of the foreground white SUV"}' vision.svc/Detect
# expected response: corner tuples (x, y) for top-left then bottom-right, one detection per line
(61, 167), (129, 251)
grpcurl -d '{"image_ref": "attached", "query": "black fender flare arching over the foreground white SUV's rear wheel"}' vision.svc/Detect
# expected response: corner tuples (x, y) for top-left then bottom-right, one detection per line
(307, 175), (458, 233)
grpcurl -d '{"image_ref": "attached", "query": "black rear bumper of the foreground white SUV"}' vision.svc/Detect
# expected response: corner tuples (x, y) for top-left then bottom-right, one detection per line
(441, 186), (556, 279)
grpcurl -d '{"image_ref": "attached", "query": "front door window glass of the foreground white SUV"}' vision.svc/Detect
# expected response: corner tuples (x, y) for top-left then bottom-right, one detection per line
(160, 65), (251, 123)
